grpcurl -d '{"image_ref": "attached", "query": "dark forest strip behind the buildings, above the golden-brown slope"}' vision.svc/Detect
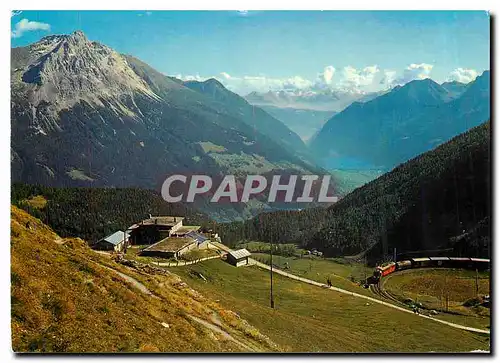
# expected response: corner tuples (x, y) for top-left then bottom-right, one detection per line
(12, 183), (208, 243)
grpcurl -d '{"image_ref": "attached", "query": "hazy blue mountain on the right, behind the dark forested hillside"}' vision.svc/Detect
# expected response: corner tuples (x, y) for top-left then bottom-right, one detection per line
(310, 71), (490, 170)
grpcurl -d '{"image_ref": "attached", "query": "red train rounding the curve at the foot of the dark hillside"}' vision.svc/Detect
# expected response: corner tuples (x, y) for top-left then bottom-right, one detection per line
(368, 257), (490, 283)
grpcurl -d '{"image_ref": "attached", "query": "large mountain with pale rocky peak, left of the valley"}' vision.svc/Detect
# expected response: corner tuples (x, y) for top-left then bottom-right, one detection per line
(11, 31), (322, 220)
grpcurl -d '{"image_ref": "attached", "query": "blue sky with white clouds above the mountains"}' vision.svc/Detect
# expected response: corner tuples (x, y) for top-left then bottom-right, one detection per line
(11, 11), (490, 94)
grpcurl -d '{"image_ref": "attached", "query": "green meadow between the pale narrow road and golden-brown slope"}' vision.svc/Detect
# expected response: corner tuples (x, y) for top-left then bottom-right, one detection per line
(169, 260), (489, 352)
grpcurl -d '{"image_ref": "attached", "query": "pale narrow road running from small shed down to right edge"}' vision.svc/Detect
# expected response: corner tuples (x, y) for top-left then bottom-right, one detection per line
(248, 258), (490, 334)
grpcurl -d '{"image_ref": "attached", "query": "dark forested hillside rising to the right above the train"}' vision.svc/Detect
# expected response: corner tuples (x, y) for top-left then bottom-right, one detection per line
(218, 122), (491, 259)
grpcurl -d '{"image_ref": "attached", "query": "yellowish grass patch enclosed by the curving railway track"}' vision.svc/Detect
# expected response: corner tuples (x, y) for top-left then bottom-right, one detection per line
(383, 268), (491, 329)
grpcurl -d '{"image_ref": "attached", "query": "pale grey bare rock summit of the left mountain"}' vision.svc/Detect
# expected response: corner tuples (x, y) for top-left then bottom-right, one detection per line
(14, 31), (160, 132)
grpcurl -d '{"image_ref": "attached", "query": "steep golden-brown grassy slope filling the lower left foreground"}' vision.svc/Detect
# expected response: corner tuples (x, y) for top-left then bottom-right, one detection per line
(11, 207), (279, 353)
